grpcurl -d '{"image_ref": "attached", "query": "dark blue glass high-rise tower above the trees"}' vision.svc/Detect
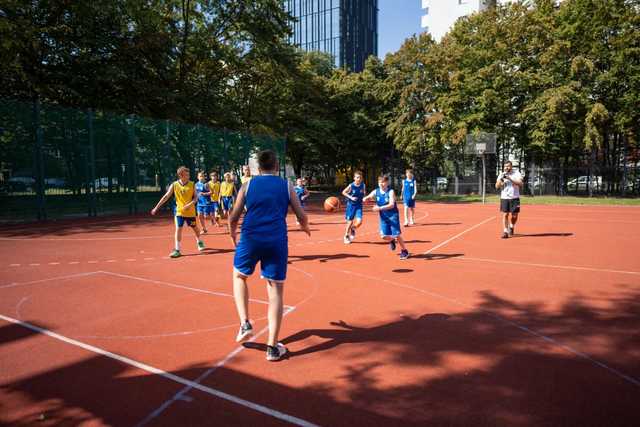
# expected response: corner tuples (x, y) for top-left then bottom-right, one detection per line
(284, 0), (378, 71)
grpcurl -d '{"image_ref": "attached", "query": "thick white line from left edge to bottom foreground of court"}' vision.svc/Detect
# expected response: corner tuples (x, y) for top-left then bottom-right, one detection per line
(0, 314), (316, 427)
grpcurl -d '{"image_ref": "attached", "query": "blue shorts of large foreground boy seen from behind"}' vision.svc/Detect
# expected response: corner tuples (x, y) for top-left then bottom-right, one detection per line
(233, 234), (289, 282)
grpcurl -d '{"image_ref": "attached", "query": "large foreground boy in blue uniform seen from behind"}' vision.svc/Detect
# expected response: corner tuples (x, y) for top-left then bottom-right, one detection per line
(229, 150), (311, 361)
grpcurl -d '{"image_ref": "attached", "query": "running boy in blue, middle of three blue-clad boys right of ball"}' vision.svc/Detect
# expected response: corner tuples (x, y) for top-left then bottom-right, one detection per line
(363, 175), (409, 259)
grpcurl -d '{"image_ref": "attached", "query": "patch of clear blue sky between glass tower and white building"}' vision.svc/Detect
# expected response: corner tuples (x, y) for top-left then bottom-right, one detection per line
(378, 0), (422, 59)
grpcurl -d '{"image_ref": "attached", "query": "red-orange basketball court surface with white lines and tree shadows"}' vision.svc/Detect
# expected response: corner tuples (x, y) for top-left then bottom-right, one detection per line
(0, 203), (640, 426)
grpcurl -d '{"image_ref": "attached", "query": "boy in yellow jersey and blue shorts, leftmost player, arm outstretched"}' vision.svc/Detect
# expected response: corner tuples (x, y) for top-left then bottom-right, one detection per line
(151, 166), (205, 258)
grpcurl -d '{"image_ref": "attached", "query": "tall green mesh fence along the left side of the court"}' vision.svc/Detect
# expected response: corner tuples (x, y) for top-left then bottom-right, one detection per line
(0, 100), (285, 221)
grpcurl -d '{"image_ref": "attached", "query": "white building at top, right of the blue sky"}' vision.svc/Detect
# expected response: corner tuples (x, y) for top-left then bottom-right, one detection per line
(421, 0), (508, 42)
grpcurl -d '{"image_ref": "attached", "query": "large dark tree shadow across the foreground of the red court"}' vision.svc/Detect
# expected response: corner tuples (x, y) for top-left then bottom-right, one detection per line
(0, 292), (640, 427)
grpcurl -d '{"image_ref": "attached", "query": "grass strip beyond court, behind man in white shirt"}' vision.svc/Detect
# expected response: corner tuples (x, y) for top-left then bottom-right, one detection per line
(417, 194), (640, 206)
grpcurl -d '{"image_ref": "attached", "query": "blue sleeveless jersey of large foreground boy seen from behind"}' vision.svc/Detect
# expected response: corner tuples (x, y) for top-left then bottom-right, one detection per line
(242, 175), (289, 242)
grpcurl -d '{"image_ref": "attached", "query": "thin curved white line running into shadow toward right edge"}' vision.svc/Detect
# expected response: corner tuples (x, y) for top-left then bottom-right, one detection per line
(330, 268), (640, 387)
